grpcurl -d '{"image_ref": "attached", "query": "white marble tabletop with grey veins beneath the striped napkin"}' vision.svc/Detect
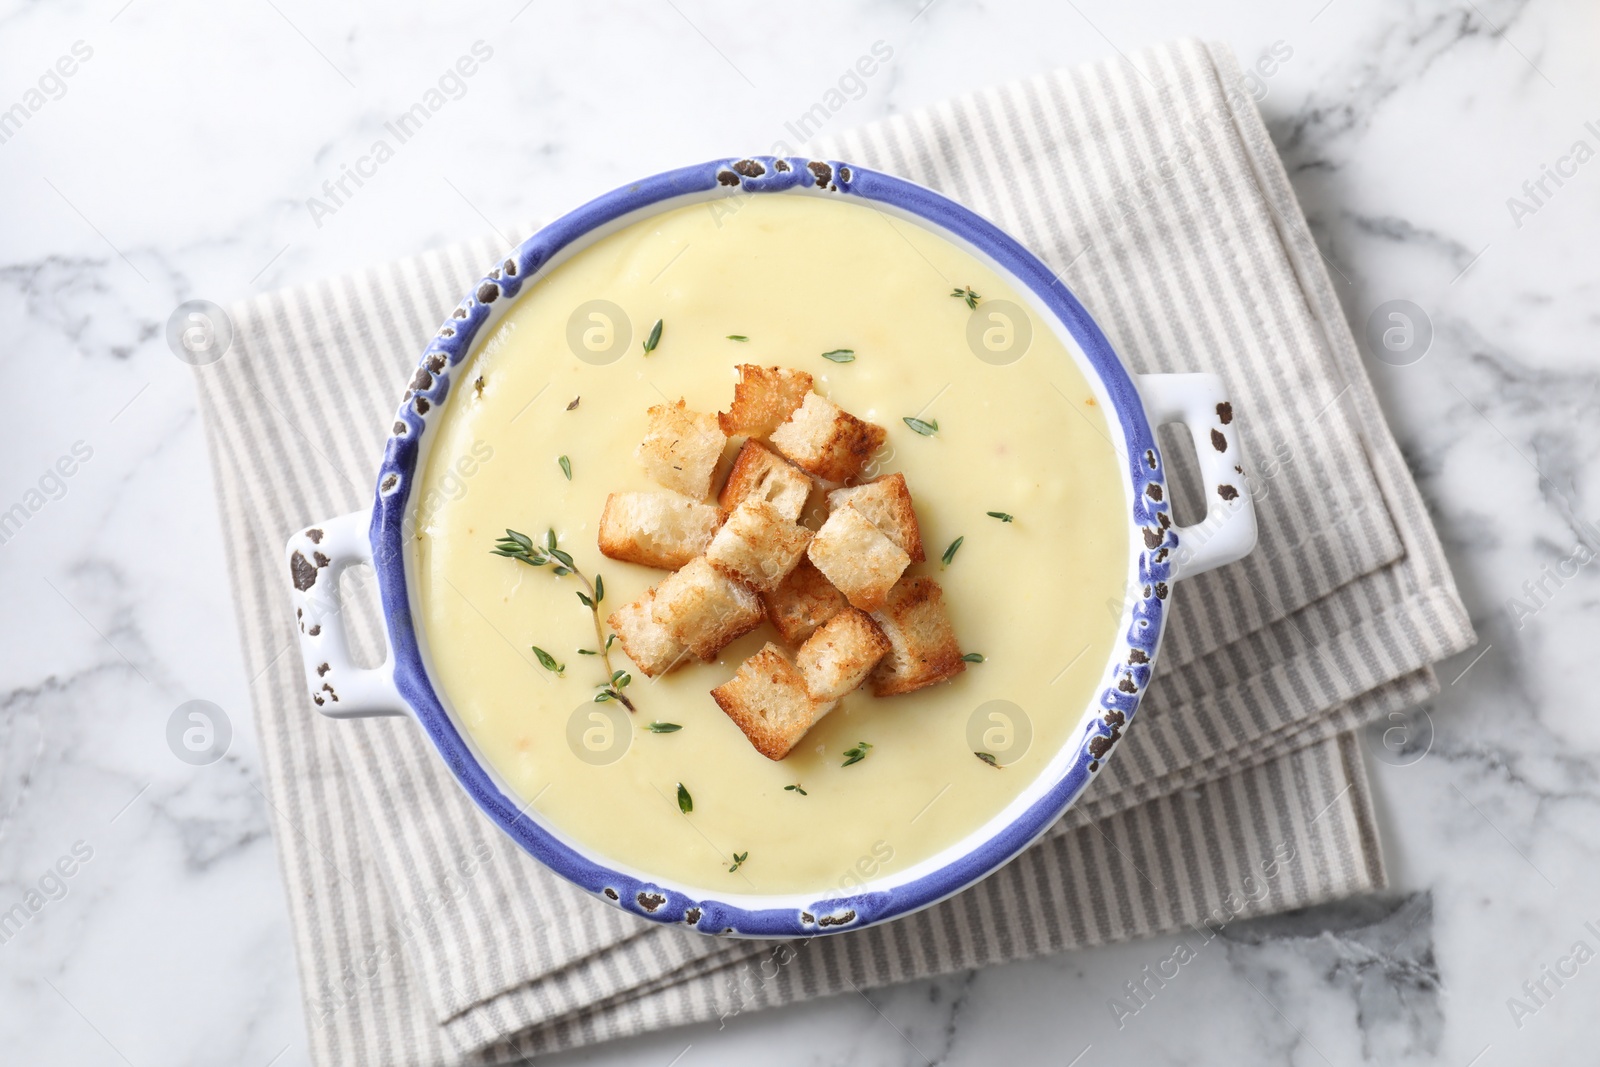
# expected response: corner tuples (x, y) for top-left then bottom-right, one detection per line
(0, 0), (1600, 1067)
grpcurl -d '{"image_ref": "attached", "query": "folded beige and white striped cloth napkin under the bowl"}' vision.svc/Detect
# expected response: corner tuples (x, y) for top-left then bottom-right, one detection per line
(198, 42), (1472, 1065)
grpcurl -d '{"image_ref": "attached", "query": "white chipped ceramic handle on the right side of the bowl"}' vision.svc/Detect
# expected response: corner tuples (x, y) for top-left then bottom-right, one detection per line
(1139, 374), (1256, 581)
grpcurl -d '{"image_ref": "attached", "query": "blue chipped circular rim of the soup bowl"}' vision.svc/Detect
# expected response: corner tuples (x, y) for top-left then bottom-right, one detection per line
(370, 155), (1178, 937)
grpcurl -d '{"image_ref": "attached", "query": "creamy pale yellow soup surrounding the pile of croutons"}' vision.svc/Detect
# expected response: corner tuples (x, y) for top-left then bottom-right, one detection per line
(413, 195), (1128, 896)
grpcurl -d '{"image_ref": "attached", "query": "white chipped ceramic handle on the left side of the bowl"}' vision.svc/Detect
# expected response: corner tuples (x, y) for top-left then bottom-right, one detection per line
(283, 512), (410, 718)
